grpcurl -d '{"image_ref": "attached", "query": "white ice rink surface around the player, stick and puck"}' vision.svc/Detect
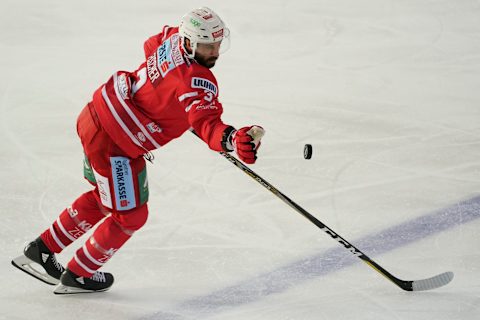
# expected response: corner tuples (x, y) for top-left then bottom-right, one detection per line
(0, 0), (480, 320)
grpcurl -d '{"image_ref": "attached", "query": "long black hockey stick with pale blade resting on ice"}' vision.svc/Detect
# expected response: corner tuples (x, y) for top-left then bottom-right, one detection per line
(192, 131), (453, 291)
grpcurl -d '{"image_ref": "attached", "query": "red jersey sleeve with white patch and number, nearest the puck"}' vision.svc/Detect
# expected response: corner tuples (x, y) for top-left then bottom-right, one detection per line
(177, 69), (231, 151)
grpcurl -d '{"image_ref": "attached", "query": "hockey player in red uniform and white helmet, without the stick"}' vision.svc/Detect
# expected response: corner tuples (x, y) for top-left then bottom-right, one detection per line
(12, 7), (263, 294)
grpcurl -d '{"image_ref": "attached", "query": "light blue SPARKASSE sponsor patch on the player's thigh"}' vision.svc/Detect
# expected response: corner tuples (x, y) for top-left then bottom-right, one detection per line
(110, 157), (136, 211)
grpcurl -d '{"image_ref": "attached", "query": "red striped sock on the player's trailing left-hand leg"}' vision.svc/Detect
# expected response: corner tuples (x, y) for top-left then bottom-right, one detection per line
(40, 190), (105, 253)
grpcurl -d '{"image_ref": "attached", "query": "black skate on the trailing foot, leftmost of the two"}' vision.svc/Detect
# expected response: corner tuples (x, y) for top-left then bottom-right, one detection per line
(12, 237), (65, 285)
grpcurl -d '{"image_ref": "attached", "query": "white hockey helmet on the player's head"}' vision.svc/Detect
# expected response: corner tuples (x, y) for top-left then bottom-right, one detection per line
(179, 7), (230, 58)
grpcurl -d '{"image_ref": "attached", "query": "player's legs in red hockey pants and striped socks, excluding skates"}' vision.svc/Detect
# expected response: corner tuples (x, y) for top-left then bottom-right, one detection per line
(41, 105), (148, 277)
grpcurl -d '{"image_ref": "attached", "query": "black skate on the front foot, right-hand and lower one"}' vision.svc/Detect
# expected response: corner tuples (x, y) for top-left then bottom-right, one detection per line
(53, 269), (113, 294)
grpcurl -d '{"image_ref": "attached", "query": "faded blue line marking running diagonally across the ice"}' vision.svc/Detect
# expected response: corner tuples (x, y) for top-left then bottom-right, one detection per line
(146, 196), (480, 320)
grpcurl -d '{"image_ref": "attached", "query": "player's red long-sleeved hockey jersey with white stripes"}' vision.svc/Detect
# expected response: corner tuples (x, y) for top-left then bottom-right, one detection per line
(93, 26), (232, 158)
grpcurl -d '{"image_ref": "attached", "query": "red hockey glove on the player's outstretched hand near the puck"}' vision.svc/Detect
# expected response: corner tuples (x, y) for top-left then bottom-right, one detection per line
(232, 126), (265, 164)
